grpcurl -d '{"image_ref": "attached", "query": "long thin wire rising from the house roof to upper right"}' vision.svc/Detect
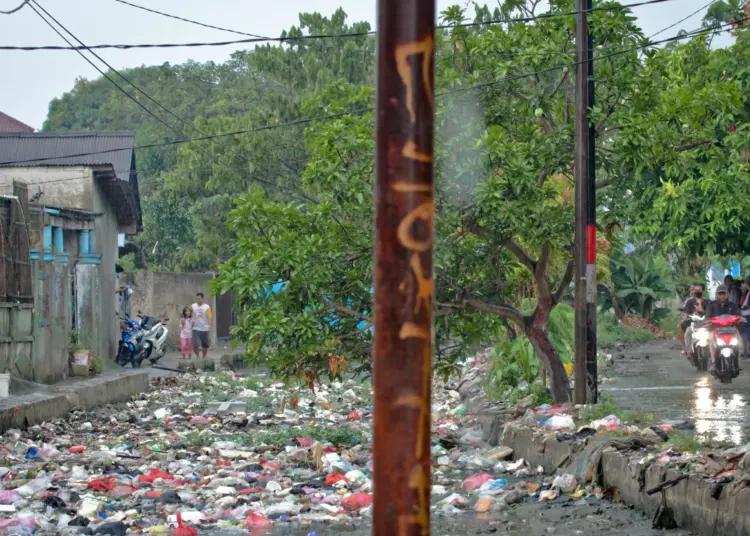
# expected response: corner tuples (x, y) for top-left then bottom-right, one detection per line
(0, 16), (750, 166)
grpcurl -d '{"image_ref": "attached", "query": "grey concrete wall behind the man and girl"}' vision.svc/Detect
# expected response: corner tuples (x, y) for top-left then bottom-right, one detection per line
(121, 272), (216, 349)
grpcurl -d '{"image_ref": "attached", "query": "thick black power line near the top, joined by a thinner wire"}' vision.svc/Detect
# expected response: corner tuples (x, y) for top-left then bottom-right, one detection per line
(0, 0), (675, 51)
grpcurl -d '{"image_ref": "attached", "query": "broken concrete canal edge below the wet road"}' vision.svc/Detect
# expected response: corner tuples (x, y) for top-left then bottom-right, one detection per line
(501, 423), (750, 536)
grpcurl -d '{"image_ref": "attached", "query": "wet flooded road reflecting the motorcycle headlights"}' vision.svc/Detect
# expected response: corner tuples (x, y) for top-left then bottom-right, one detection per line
(600, 340), (750, 445)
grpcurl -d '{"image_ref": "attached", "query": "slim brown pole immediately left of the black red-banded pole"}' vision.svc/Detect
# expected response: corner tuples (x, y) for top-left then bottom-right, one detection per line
(575, 0), (590, 404)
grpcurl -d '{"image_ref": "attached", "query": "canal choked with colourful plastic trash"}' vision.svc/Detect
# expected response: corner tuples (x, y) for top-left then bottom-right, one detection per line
(0, 373), (685, 536)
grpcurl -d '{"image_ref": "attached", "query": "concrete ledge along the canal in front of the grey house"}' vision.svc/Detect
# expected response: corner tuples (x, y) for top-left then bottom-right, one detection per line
(0, 370), (149, 433)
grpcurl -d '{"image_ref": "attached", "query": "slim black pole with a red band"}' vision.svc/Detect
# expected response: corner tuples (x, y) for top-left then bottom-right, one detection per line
(586, 0), (599, 404)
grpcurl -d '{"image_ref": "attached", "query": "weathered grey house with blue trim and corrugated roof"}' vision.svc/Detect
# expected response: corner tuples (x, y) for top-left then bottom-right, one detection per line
(0, 132), (142, 383)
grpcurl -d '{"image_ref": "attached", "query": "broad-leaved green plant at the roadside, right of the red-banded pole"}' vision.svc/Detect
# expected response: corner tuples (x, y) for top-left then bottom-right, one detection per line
(599, 253), (675, 321)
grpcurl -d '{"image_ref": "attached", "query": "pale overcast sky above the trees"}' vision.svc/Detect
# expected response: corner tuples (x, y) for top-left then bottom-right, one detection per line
(0, 0), (736, 129)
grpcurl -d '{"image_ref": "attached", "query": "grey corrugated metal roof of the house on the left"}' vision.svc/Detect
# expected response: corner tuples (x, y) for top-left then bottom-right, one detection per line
(0, 131), (135, 182)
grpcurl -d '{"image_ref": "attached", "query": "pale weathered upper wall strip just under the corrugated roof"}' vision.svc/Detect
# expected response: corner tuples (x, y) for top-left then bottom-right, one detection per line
(0, 166), (94, 210)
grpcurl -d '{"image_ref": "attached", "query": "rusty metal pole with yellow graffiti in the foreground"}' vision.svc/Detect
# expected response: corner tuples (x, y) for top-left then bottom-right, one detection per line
(373, 0), (435, 536)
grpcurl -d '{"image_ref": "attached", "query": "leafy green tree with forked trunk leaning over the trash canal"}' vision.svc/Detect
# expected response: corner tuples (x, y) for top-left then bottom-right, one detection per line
(217, 2), (643, 401)
